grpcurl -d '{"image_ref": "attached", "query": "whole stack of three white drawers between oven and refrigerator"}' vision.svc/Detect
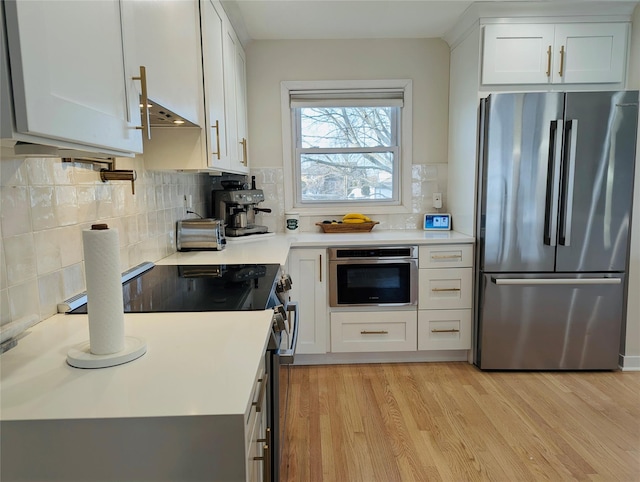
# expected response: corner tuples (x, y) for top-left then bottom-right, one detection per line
(418, 245), (473, 350)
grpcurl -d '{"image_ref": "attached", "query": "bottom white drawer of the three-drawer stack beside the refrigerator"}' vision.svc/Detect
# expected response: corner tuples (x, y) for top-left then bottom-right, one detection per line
(418, 310), (471, 350)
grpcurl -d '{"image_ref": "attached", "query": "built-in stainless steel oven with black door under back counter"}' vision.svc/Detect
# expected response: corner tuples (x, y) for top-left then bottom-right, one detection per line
(329, 246), (418, 307)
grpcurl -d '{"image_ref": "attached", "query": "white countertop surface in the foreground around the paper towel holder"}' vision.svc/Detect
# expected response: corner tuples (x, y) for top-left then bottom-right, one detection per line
(0, 310), (272, 420)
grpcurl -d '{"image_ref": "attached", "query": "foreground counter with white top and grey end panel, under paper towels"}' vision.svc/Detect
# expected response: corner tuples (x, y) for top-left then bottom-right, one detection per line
(0, 310), (272, 482)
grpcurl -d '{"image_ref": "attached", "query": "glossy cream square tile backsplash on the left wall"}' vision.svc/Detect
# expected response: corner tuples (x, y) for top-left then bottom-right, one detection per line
(0, 158), (211, 325)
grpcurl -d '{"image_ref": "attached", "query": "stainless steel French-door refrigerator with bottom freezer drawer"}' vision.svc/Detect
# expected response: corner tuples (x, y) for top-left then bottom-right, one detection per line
(474, 91), (638, 370)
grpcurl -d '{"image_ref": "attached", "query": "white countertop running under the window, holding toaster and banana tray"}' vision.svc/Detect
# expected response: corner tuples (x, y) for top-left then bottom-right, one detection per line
(156, 228), (474, 265)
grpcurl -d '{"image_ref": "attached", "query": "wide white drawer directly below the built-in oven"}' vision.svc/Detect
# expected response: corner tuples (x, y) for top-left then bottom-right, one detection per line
(331, 311), (418, 352)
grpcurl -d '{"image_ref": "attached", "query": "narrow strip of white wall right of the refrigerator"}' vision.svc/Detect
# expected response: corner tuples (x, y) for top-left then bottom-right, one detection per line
(623, 4), (640, 369)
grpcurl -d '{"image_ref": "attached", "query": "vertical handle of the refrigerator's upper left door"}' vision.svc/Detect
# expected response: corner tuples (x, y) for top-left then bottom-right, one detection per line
(544, 119), (563, 246)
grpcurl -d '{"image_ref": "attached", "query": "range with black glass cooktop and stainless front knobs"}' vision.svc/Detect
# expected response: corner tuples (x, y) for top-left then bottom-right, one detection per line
(59, 262), (298, 481)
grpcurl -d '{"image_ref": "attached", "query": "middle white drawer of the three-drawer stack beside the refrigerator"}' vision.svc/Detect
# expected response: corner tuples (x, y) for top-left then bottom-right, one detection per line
(418, 268), (472, 310)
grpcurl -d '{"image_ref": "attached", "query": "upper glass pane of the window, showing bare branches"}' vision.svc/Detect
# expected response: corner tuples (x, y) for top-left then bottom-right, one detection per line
(300, 107), (397, 149)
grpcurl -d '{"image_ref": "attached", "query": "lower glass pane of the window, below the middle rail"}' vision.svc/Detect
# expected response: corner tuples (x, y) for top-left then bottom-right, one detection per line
(300, 151), (394, 202)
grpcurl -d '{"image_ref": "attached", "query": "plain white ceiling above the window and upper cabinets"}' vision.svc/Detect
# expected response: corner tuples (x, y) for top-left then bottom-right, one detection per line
(222, 0), (637, 44)
